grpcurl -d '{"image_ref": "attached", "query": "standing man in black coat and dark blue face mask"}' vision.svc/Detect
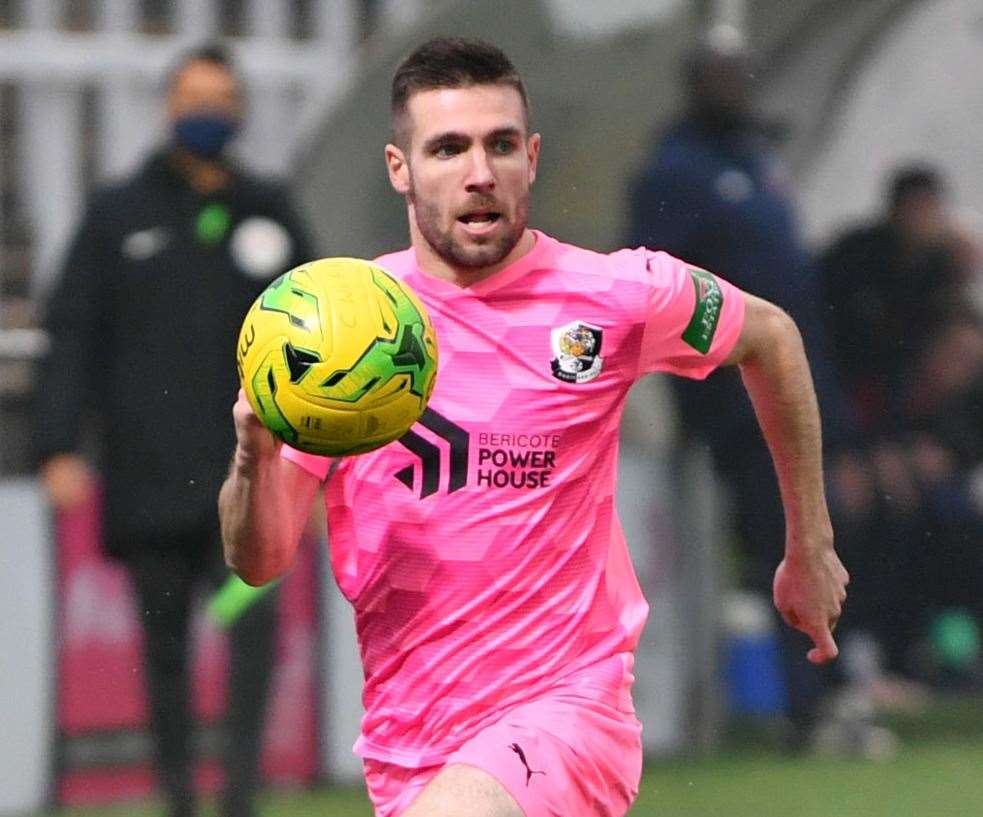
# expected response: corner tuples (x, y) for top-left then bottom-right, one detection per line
(36, 46), (312, 817)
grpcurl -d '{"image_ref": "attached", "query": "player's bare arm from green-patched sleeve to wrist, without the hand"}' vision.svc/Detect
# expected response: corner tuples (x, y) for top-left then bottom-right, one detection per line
(740, 308), (833, 550)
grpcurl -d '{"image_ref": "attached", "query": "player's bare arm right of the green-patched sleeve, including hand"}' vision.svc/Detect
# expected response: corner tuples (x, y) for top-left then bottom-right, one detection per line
(727, 295), (849, 664)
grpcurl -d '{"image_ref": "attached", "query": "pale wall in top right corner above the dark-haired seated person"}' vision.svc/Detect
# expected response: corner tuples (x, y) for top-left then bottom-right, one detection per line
(801, 0), (983, 242)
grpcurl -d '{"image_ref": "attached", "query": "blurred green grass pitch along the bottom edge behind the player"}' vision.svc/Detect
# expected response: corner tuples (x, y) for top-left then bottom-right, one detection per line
(42, 737), (983, 817)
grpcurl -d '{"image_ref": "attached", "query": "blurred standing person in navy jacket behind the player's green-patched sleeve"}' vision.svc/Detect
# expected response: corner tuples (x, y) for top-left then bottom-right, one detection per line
(628, 27), (850, 745)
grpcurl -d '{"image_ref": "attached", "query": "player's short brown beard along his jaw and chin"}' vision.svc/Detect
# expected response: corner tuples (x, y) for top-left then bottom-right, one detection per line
(407, 182), (529, 269)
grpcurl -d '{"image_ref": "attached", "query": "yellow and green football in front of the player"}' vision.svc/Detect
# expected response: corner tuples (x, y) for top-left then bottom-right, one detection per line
(236, 258), (437, 456)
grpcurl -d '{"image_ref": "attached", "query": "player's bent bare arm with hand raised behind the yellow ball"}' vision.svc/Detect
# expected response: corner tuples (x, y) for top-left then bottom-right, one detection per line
(218, 390), (320, 585)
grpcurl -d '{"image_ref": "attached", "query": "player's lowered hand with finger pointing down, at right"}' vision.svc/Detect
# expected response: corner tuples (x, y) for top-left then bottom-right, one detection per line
(774, 544), (850, 664)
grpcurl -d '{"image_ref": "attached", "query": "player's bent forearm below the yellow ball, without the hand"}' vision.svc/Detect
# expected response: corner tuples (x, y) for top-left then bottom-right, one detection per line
(218, 448), (300, 585)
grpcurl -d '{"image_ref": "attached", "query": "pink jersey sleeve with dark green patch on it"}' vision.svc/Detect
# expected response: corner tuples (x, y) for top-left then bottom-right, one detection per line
(639, 250), (744, 380)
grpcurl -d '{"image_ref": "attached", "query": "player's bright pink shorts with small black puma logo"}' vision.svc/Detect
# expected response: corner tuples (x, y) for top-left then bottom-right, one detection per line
(365, 693), (642, 817)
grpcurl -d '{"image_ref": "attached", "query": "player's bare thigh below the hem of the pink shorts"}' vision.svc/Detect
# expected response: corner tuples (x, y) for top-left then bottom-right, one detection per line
(400, 763), (525, 817)
